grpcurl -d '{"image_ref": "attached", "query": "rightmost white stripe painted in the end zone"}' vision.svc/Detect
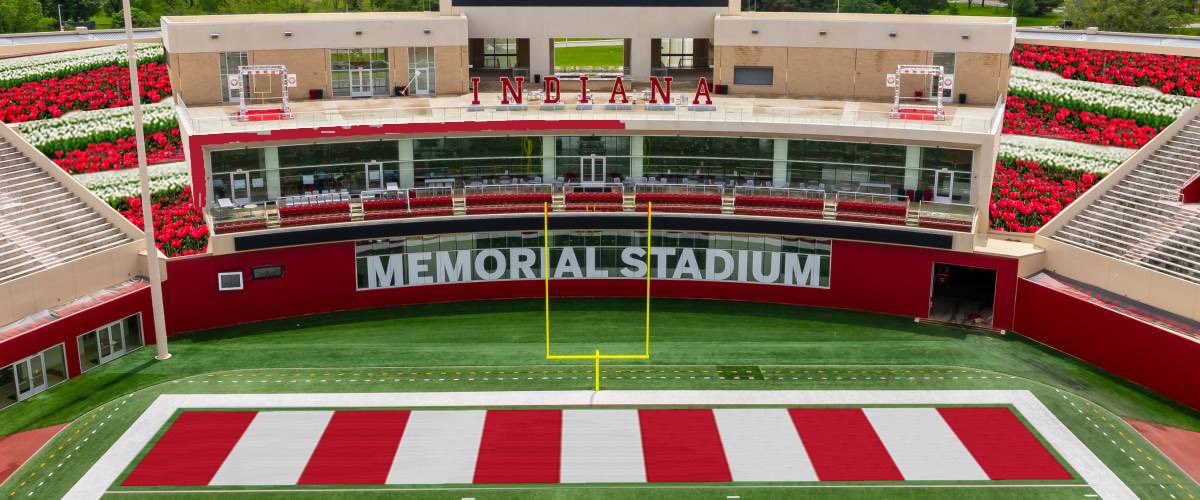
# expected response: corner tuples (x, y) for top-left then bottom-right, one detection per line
(863, 408), (988, 481)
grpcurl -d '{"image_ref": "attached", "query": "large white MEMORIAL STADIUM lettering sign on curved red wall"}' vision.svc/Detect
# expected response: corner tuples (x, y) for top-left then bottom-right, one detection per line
(358, 247), (829, 290)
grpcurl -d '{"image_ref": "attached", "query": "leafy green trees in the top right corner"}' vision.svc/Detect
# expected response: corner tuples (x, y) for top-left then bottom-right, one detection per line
(1063, 0), (1192, 34)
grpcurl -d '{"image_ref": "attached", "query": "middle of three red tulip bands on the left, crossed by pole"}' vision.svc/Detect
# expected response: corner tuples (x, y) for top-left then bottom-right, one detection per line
(49, 128), (184, 174)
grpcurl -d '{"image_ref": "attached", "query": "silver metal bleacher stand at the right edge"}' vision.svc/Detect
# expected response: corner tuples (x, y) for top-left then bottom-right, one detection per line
(1051, 113), (1200, 283)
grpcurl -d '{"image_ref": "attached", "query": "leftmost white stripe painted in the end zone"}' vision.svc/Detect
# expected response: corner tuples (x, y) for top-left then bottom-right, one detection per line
(209, 411), (334, 486)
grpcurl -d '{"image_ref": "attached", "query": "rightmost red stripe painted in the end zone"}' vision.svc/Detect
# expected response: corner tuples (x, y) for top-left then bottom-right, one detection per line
(937, 408), (1074, 480)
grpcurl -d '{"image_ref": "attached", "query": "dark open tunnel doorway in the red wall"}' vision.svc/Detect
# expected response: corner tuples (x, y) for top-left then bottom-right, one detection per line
(929, 264), (996, 329)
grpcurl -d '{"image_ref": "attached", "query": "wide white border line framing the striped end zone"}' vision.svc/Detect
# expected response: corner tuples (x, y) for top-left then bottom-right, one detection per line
(66, 390), (1136, 499)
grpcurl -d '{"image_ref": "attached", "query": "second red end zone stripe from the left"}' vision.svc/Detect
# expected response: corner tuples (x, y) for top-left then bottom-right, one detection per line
(299, 411), (408, 484)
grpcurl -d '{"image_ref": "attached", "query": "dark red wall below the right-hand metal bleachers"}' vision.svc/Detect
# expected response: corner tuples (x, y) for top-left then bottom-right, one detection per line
(1013, 279), (1200, 410)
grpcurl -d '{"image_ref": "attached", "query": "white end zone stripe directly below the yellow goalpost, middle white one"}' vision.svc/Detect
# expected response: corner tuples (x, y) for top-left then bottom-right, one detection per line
(559, 410), (646, 483)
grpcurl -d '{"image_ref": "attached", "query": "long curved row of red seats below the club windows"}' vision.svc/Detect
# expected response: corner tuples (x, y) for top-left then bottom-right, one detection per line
(217, 192), (971, 233)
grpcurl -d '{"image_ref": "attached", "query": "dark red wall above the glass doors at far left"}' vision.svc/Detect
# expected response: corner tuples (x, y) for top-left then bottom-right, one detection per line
(0, 288), (154, 376)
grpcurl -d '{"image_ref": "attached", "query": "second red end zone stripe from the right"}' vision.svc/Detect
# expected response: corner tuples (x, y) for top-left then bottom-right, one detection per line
(787, 408), (904, 481)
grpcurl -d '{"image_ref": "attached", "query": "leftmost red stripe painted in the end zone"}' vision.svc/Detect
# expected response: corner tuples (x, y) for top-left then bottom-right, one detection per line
(121, 411), (258, 486)
